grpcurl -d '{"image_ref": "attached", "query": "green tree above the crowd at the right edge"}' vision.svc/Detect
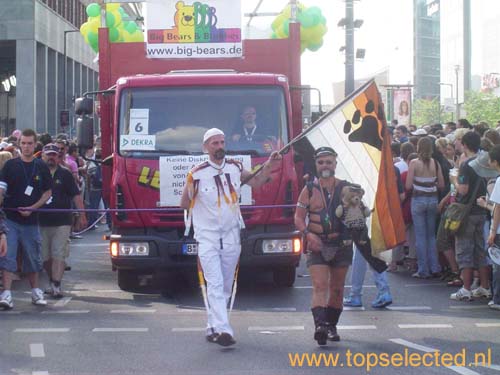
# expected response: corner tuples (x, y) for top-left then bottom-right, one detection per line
(463, 91), (500, 126)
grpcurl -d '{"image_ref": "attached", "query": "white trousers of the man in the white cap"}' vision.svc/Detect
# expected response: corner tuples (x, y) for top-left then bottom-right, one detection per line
(198, 241), (241, 336)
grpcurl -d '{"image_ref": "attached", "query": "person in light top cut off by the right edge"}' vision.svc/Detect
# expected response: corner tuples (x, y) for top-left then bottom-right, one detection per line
(488, 145), (500, 310)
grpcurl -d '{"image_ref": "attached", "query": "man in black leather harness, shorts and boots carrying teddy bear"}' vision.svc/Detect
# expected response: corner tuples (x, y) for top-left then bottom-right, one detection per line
(295, 147), (353, 345)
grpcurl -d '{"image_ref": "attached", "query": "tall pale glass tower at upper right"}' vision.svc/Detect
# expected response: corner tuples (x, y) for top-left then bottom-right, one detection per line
(413, 0), (440, 99)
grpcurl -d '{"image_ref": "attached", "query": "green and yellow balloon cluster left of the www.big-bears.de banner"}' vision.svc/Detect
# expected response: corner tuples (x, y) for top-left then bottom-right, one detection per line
(80, 3), (144, 52)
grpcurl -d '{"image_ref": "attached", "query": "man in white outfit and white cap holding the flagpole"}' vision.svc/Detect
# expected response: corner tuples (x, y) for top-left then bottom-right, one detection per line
(180, 128), (282, 346)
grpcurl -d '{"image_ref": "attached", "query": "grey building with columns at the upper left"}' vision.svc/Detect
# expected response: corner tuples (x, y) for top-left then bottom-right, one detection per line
(0, 0), (98, 136)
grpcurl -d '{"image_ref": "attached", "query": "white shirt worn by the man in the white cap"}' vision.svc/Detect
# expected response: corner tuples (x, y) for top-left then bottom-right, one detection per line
(190, 159), (242, 244)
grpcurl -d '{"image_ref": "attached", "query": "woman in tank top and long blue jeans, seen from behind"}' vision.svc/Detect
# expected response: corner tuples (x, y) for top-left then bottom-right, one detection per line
(406, 137), (444, 278)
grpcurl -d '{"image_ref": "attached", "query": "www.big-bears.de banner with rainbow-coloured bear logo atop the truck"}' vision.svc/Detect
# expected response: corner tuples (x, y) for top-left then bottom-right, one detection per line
(145, 0), (243, 59)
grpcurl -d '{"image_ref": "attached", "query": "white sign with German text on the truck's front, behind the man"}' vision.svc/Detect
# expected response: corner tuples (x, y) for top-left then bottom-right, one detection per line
(158, 155), (252, 207)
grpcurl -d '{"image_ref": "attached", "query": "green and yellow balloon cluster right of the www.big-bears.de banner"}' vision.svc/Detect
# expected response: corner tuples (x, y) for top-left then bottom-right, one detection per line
(271, 3), (328, 52)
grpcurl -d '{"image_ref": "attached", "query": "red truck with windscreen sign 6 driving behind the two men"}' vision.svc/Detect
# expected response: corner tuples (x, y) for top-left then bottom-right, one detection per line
(77, 24), (302, 290)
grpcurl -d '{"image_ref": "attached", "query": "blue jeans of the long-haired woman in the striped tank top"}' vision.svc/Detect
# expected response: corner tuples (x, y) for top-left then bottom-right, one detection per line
(411, 196), (441, 276)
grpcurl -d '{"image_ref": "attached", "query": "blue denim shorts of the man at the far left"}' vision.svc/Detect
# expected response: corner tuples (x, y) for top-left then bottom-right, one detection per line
(0, 219), (42, 273)
